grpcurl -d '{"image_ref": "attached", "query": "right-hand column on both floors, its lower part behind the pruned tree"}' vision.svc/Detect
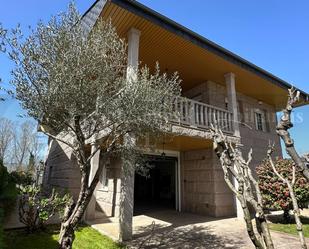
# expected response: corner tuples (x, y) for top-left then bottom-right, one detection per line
(224, 73), (244, 219)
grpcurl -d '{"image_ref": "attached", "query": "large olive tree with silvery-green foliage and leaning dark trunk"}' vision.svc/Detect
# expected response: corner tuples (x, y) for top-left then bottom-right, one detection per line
(0, 4), (180, 248)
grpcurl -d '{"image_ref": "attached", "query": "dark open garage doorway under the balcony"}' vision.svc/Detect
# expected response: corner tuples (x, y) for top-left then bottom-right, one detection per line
(134, 156), (177, 215)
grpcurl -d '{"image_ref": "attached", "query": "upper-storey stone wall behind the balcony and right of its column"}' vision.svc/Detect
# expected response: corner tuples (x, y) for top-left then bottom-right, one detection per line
(184, 81), (282, 166)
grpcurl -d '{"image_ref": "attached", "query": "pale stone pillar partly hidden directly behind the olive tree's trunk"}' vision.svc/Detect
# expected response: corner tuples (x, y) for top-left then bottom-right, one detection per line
(85, 142), (100, 220)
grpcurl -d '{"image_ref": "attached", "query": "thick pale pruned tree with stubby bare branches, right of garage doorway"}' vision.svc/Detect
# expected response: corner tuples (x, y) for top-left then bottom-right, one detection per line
(211, 125), (274, 249)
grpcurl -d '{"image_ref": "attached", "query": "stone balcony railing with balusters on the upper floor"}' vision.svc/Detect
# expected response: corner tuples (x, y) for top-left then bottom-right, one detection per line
(171, 97), (233, 133)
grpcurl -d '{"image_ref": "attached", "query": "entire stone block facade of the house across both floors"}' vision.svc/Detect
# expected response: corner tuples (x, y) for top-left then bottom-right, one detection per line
(44, 81), (282, 223)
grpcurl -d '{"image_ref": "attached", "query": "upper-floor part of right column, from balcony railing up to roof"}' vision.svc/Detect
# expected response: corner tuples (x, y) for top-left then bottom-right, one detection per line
(224, 73), (240, 137)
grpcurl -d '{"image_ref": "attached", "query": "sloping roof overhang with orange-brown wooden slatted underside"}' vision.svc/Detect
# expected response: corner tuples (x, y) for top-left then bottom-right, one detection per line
(83, 0), (309, 110)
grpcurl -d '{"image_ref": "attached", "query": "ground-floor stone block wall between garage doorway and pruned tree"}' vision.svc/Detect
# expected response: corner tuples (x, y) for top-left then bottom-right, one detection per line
(181, 148), (235, 217)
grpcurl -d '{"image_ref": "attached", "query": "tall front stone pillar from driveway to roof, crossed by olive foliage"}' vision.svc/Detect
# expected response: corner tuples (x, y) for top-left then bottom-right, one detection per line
(119, 28), (141, 241)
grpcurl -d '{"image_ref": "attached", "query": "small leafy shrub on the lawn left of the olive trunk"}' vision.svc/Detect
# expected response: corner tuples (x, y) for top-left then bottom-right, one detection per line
(19, 185), (70, 233)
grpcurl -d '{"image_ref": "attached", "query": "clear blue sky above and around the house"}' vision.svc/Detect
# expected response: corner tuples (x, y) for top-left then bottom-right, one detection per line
(0, 0), (309, 156)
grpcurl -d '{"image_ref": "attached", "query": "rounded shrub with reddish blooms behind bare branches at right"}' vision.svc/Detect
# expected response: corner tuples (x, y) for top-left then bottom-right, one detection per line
(257, 159), (309, 210)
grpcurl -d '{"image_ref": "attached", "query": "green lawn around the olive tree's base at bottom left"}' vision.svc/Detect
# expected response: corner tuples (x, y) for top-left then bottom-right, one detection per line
(4, 226), (124, 249)
